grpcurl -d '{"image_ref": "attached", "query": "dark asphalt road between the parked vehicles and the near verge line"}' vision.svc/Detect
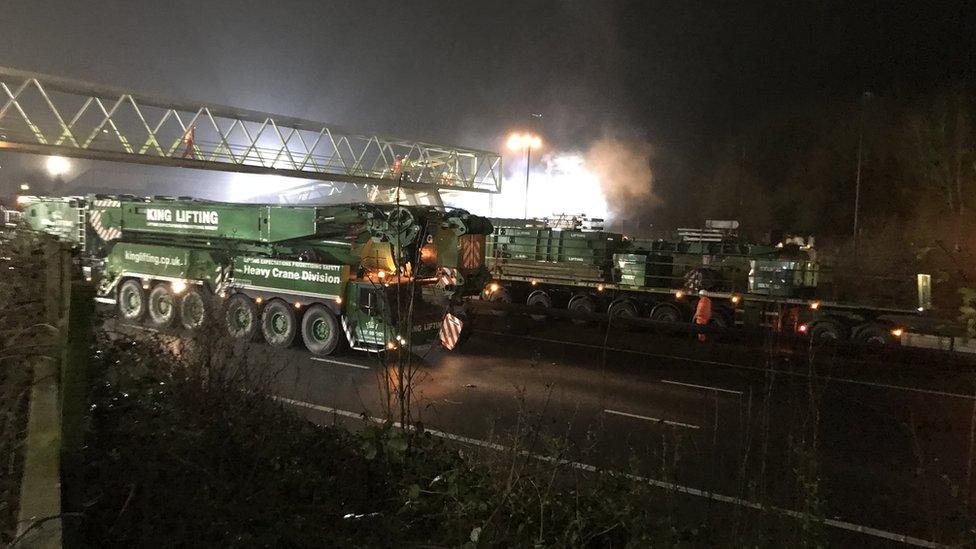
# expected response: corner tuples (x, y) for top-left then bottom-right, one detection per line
(118, 317), (976, 541)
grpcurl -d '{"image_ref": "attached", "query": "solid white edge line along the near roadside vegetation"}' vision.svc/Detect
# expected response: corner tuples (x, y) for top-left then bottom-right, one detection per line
(271, 395), (944, 549)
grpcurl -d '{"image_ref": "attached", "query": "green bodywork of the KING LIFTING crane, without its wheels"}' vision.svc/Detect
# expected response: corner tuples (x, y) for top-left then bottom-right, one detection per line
(24, 195), (493, 350)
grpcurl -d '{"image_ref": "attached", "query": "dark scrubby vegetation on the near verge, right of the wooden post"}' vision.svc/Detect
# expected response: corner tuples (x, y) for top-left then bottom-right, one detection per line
(65, 328), (724, 547)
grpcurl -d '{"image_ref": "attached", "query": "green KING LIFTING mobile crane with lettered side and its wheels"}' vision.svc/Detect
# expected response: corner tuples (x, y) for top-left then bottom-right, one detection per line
(23, 196), (491, 354)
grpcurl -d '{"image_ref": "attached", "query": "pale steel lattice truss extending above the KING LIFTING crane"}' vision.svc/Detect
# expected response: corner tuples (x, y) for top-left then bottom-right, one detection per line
(0, 67), (502, 192)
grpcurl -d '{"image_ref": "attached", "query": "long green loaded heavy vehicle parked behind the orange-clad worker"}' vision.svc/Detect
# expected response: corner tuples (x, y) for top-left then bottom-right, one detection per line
(481, 220), (929, 343)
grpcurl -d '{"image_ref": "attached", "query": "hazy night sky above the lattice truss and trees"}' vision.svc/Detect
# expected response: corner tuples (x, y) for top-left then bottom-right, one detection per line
(0, 0), (976, 225)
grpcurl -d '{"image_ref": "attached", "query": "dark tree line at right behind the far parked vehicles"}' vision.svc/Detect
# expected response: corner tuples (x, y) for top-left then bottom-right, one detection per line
(655, 89), (976, 307)
